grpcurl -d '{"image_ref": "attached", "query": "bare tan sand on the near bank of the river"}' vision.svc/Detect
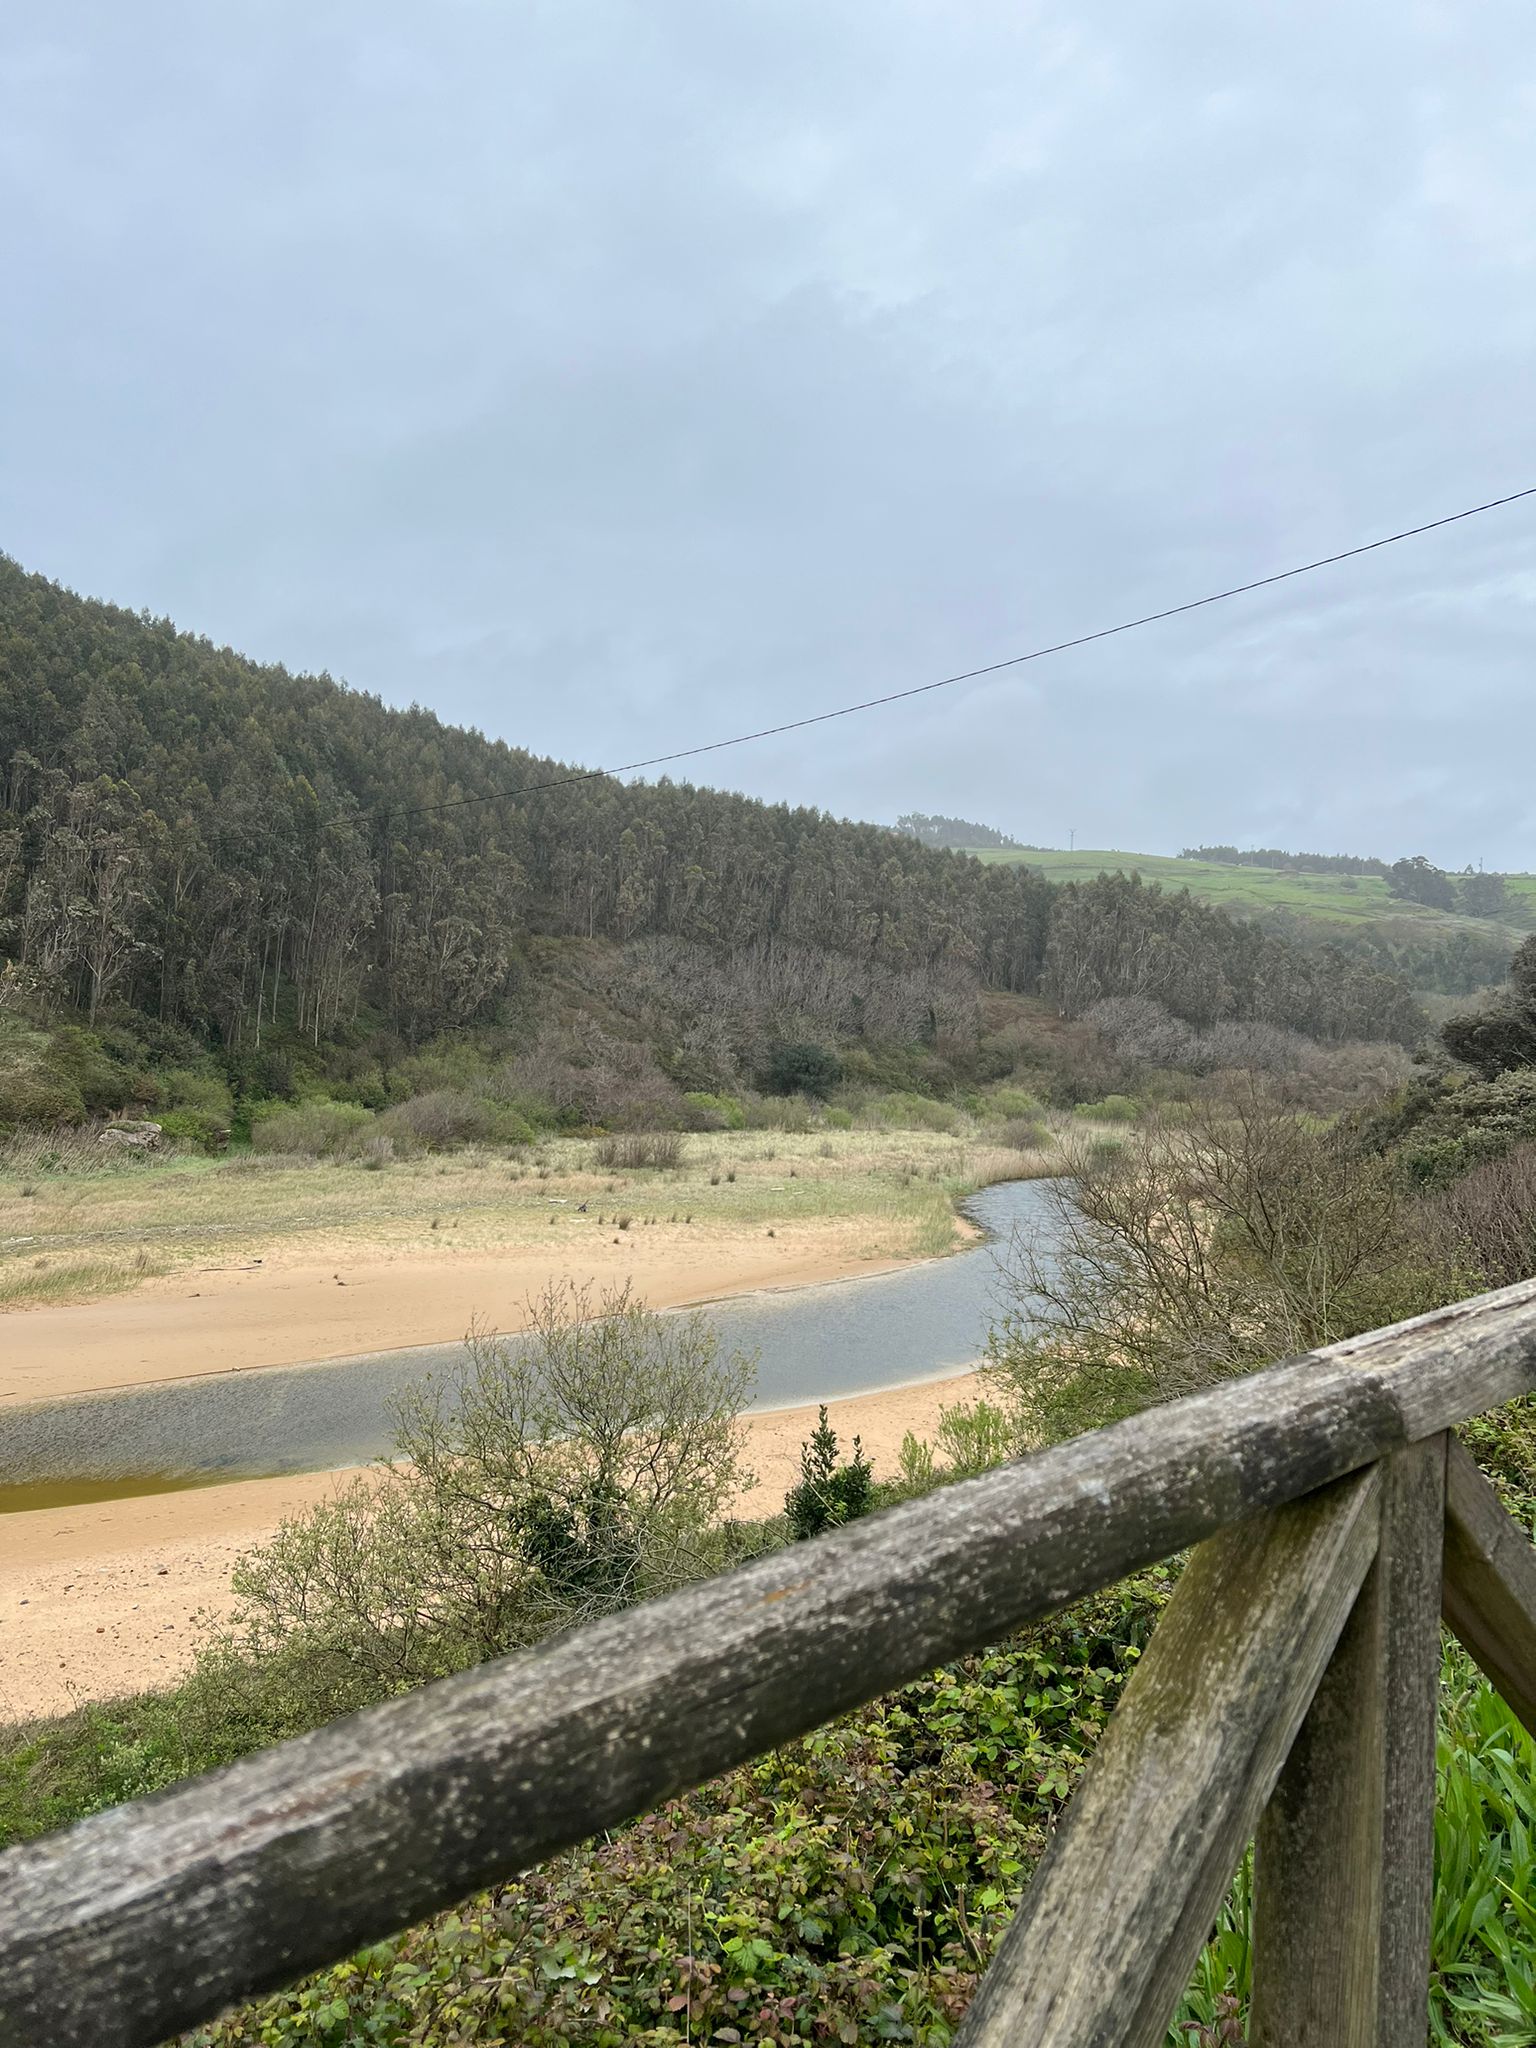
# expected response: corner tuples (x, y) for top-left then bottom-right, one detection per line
(0, 1368), (977, 1720)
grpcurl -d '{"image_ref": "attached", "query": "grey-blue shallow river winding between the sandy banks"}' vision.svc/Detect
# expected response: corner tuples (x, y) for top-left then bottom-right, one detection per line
(0, 1180), (1053, 1511)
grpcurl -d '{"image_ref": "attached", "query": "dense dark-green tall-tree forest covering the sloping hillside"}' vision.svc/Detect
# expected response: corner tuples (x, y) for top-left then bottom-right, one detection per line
(0, 557), (1421, 1105)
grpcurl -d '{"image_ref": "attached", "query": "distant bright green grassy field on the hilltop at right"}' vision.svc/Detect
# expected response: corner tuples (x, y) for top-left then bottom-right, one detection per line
(975, 846), (1536, 936)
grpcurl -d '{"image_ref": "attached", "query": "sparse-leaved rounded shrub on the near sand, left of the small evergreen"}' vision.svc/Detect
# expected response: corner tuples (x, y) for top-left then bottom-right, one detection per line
(209, 1286), (754, 1710)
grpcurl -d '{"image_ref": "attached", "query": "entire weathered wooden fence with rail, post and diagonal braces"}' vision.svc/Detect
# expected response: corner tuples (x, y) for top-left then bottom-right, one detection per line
(0, 1282), (1536, 2048)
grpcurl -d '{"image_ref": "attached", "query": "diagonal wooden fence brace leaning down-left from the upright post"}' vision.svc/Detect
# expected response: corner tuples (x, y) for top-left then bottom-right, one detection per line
(956, 1466), (1378, 2048)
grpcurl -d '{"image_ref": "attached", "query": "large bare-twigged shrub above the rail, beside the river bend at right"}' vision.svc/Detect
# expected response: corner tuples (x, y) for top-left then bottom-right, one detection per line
(989, 1081), (1466, 1440)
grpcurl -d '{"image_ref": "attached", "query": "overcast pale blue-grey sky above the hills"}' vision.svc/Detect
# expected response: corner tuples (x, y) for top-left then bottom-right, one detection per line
(0, 0), (1536, 868)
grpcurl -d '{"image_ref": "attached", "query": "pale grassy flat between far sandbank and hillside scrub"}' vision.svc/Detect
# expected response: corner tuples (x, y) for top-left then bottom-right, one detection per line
(0, 1118), (1083, 1307)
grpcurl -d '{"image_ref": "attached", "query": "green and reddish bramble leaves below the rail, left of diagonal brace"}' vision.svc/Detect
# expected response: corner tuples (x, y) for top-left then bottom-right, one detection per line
(180, 1575), (1165, 2048)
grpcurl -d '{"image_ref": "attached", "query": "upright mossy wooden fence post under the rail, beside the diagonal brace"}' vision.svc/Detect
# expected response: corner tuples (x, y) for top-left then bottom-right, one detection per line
(1249, 1436), (1446, 2048)
